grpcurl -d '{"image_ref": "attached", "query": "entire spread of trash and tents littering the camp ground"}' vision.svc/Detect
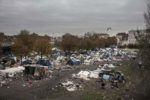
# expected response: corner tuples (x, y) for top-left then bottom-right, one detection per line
(0, 48), (136, 91)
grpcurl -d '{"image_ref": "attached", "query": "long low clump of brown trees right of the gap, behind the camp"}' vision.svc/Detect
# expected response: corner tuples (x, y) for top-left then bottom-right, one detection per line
(57, 33), (117, 51)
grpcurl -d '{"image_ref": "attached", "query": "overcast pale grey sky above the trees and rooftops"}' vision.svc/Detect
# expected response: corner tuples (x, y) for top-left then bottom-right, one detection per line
(0, 0), (146, 35)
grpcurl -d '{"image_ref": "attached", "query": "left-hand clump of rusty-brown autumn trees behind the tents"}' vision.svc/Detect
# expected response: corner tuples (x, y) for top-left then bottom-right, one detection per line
(0, 30), (52, 57)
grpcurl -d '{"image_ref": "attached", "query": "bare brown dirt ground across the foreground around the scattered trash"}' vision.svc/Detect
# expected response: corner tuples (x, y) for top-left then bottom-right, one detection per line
(0, 61), (130, 100)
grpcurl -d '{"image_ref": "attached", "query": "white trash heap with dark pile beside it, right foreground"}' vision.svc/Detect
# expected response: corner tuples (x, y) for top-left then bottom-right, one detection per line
(72, 64), (125, 88)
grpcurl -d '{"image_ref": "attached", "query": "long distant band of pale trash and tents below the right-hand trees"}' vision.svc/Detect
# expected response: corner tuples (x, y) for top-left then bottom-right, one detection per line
(52, 48), (136, 66)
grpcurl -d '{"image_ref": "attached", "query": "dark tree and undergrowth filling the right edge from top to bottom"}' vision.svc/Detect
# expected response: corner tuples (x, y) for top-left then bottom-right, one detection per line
(133, 1), (150, 100)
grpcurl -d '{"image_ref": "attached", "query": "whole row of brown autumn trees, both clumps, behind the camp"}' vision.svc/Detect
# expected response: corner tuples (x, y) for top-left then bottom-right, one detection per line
(0, 30), (117, 57)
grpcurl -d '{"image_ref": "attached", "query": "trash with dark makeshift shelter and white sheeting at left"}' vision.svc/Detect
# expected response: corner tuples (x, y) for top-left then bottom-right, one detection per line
(0, 56), (51, 86)
